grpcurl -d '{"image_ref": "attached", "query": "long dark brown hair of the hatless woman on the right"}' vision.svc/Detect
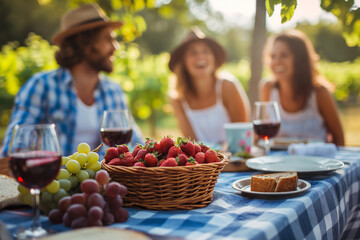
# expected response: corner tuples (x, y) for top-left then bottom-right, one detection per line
(267, 30), (319, 107)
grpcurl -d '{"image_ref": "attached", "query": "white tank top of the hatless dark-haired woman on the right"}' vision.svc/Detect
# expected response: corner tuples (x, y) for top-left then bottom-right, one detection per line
(270, 88), (327, 141)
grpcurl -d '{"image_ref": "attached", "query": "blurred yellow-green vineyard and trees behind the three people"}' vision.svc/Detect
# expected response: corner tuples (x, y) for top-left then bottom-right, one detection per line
(0, 0), (360, 145)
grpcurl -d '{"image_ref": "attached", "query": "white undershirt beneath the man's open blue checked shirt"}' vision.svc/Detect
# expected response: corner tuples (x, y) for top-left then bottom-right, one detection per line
(72, 98), (100, 152)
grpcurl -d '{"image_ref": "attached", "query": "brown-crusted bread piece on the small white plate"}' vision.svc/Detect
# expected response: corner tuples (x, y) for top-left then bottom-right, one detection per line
(250, 172), (298, 192)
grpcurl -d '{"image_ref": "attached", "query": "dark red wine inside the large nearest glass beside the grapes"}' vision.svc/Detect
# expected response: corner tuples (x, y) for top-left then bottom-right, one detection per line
(9, 151), (61, 188)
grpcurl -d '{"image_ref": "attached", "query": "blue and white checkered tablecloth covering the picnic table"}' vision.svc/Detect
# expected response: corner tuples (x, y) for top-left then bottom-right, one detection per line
(0, 148), (360, 240)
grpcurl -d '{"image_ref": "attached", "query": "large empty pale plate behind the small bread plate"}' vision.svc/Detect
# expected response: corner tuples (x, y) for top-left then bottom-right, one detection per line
(246, 155), (344, 174)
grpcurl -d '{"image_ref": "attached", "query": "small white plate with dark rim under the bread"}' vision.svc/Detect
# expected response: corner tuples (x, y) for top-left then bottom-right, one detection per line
(232, 178), (311, 198)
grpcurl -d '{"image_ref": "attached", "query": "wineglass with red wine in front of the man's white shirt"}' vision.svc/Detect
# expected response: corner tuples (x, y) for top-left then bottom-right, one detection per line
(100, 110), (133, 147)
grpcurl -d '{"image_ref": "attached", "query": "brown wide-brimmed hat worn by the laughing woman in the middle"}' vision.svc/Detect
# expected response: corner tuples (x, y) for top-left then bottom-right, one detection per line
(169, 28), (227, 71)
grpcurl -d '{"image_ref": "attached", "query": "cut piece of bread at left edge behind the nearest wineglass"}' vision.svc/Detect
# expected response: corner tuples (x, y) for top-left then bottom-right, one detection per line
(0, 174), (21, 209)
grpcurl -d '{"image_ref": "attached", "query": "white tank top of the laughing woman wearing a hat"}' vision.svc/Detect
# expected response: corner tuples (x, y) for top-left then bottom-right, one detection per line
(182, 79), (230, 144)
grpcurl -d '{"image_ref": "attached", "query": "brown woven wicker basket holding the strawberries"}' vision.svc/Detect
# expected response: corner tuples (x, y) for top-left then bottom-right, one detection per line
(101, 155), (229, 210)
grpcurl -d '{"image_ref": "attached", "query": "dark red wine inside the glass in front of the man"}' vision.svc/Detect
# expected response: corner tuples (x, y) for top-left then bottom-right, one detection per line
(101, 128), (132, 147)
